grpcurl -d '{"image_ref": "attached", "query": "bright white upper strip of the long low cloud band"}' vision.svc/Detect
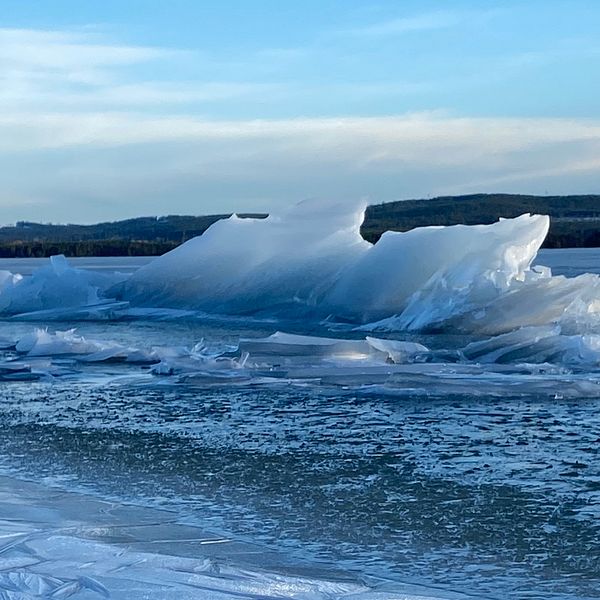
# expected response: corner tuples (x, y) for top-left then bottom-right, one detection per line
(0, 112), (600, 155)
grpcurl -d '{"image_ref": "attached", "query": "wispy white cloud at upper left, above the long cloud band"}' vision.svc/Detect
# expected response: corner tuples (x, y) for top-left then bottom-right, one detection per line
(0, 28), (284, 112)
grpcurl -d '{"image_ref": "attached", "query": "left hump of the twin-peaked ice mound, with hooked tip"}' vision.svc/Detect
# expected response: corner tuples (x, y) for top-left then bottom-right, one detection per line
(122, 203), (371, 319)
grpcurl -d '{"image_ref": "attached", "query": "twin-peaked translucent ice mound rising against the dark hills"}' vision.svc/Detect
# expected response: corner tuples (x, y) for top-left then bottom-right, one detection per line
(121, 203), (560, 329)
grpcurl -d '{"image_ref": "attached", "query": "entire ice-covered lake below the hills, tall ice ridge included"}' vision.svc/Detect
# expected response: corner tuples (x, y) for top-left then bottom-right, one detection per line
(0, 203), (600, 600)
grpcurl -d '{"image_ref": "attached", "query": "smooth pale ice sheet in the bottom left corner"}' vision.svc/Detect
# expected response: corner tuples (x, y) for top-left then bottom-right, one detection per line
(0, 477), (463, 600)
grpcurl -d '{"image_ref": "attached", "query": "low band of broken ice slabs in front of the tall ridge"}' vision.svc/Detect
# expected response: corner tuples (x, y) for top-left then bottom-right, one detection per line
(0, 326), (600, 397)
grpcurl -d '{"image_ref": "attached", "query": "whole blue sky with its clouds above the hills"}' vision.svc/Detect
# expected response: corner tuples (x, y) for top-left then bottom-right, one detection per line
(0, 0), (600, 224)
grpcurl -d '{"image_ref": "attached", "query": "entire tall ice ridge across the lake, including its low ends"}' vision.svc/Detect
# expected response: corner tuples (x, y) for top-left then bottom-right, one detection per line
(0, 202), (600, 342)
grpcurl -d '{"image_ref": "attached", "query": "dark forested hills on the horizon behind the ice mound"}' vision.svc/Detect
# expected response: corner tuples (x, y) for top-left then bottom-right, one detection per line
(0, 194), (600, 257)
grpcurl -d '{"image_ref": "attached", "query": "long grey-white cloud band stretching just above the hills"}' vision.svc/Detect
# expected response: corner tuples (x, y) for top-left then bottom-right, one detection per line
(0, 113), (600, 221)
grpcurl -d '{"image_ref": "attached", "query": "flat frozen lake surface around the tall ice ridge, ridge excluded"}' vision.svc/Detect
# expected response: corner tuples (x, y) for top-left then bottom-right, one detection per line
(0, 249), (600, 600)
